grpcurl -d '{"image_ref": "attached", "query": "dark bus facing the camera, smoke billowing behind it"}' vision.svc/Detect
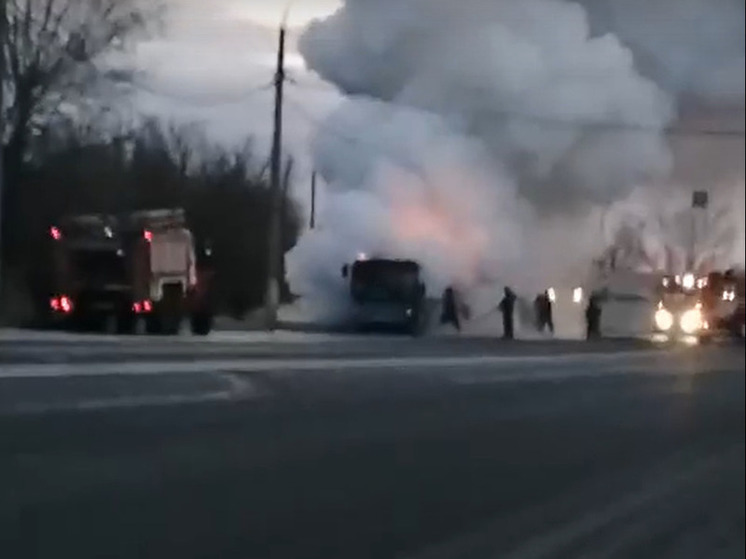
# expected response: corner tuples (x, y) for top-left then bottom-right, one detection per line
(342, 255), (426, 335)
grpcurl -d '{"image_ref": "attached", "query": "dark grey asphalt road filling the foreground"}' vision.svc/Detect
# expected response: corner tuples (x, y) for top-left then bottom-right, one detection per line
(0, 333), (746, 559)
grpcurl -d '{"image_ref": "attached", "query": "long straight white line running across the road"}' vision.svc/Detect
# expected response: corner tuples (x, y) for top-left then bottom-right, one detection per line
(0, 350), (662, 379)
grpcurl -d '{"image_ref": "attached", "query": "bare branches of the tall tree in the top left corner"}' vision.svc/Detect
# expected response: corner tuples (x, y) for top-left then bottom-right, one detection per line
(4, 0), (160, 188)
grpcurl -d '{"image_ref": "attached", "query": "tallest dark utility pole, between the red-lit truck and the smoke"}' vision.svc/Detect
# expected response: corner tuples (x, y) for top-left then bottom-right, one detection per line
(264, 23), (285, 330)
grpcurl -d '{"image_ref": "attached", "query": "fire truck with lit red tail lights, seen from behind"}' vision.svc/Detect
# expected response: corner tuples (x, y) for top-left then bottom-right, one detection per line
(49, 209), (213, 335)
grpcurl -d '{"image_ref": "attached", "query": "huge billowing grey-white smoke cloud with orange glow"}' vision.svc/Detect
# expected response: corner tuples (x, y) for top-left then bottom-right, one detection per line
(288, 0), (674, 316)
